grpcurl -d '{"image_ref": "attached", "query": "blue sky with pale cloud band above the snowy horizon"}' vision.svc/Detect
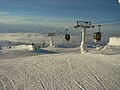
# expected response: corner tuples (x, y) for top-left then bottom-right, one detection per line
(0, 0), (120, 33)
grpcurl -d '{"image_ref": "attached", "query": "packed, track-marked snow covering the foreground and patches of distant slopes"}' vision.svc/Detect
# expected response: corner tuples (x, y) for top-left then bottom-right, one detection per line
(0, 34), (120, 90)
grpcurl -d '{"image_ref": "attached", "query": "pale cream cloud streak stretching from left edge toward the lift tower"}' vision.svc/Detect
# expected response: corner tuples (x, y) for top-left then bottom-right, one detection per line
(0, 12), (73, 28)
